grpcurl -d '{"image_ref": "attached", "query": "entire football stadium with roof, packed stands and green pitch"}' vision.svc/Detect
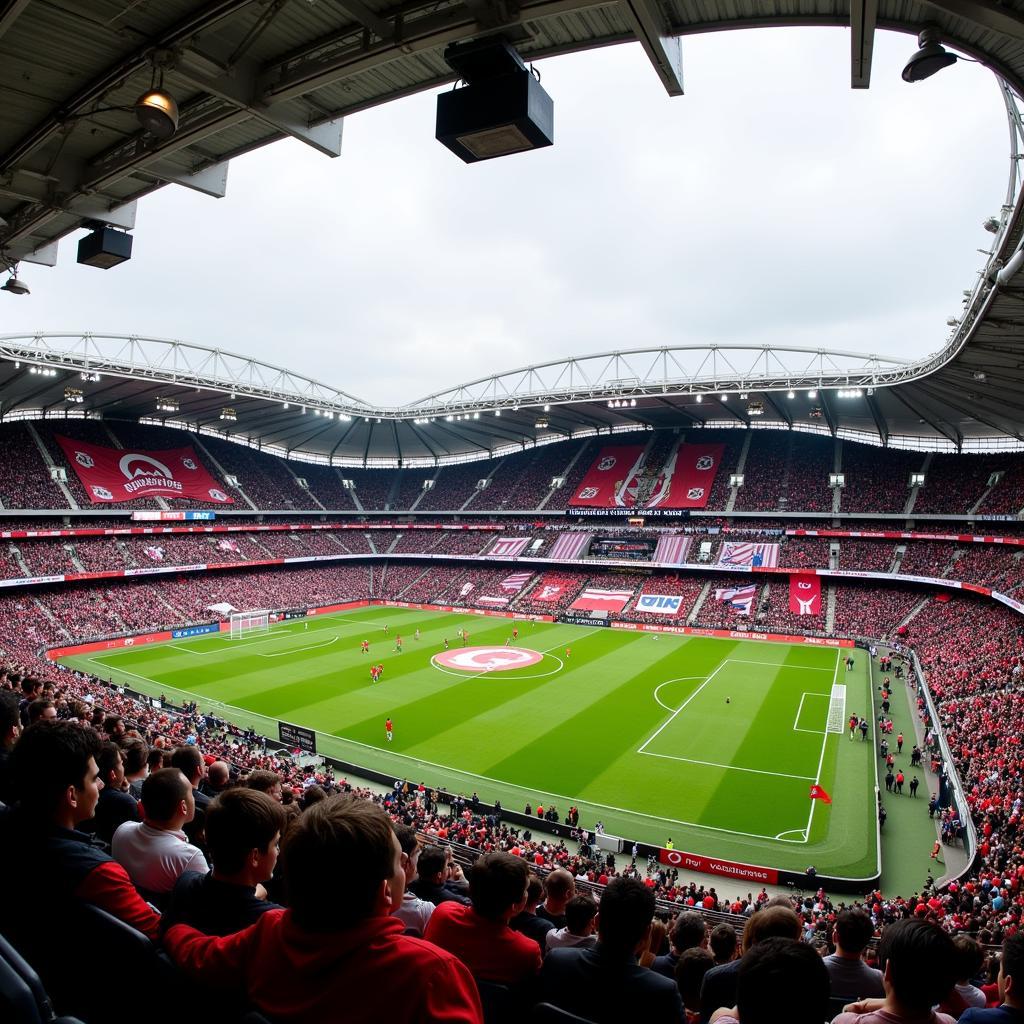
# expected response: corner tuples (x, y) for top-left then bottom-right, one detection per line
(0, 0), (1024, 1024)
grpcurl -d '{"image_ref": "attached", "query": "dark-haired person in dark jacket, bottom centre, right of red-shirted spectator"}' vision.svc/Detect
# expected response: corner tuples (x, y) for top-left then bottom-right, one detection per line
(541, 878), (684, 1024)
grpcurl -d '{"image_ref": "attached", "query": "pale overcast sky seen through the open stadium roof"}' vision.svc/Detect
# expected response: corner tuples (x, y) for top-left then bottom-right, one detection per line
(0, 29), (1008, 404)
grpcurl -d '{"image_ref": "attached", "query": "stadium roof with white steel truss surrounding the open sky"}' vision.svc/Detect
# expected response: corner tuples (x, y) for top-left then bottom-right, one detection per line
(0, 0), (1024, 463)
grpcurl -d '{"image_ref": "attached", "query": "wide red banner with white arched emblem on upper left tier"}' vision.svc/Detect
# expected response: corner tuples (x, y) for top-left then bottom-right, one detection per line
(56, 435), (234, 505)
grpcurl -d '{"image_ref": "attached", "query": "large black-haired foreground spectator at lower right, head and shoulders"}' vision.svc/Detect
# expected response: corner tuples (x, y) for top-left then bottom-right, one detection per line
(833, 918), (956, 1024)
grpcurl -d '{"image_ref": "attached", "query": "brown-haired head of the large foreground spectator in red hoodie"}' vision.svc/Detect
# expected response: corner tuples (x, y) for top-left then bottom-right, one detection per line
(283, 796), (407, 932)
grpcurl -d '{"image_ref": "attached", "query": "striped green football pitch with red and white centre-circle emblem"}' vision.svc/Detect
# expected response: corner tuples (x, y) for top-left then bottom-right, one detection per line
(62, 607), (878, 879)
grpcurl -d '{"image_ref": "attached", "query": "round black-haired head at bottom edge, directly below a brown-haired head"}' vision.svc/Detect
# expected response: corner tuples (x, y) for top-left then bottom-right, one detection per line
(736, 937), (831, 1024)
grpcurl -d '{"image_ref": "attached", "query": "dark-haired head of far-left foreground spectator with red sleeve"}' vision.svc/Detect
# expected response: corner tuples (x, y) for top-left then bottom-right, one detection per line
(10, 721), (103, 828)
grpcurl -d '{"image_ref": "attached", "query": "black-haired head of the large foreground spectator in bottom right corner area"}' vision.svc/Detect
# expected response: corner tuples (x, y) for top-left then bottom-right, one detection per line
(879, 918), (956, 1016)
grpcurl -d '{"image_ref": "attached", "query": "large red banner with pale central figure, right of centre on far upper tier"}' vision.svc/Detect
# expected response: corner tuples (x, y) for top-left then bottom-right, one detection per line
(569, 442), (725, 509)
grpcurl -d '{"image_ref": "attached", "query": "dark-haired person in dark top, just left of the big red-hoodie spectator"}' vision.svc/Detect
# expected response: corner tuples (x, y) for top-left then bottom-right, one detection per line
(162, 787), (285, 935)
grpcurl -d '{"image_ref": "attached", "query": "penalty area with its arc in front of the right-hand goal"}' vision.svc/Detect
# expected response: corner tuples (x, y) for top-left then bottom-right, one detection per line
(637, 658), (846, 784)
